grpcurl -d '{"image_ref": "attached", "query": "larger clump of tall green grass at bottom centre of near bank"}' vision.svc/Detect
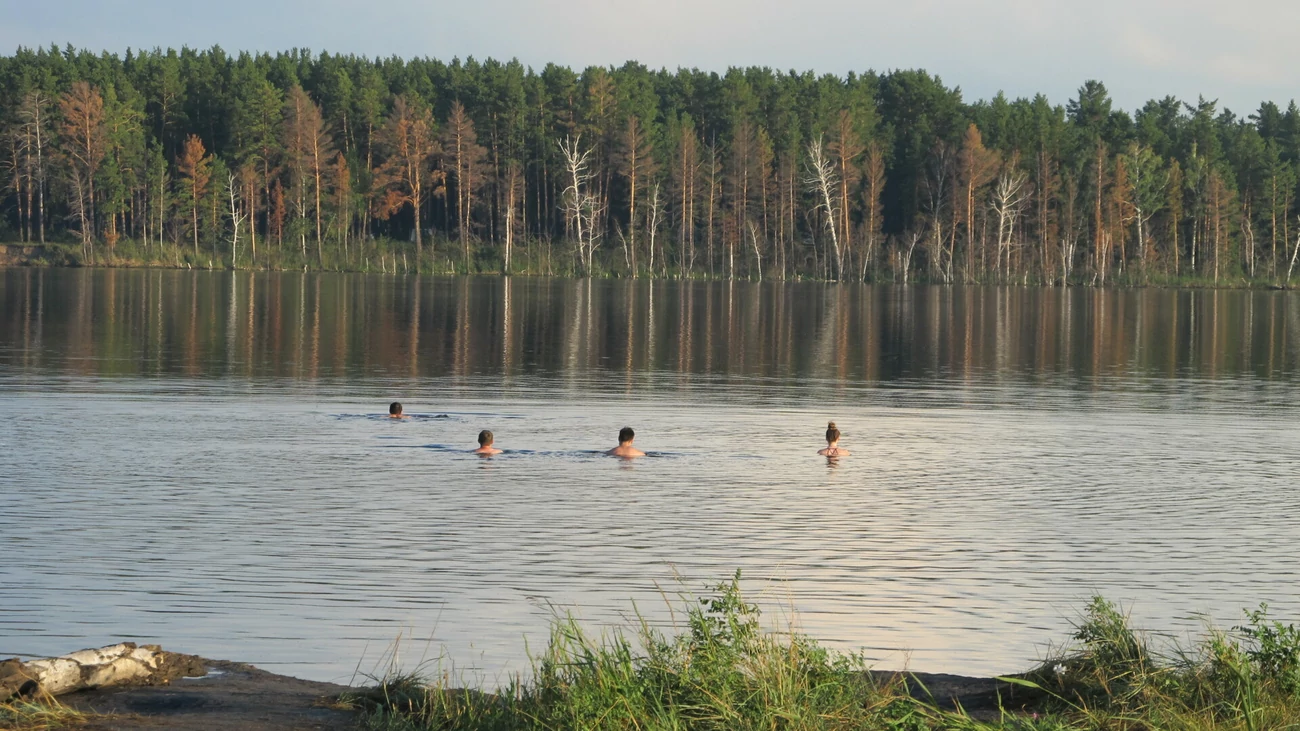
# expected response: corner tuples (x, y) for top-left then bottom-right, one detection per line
(347, 575), (932, 731)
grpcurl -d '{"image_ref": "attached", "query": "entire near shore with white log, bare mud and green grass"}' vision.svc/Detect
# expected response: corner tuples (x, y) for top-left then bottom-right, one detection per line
(12, 587), (1300, 731)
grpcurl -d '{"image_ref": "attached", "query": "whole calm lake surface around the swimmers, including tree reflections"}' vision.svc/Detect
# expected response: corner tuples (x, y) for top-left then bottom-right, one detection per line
(0, 269), (1300, 682)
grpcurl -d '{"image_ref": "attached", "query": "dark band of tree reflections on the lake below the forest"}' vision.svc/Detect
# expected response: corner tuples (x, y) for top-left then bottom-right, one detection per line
(10, 269), (1300, 385)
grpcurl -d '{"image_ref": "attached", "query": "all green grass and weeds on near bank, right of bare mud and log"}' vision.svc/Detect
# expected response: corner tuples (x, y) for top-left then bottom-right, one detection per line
(343, 572), (1300, 731)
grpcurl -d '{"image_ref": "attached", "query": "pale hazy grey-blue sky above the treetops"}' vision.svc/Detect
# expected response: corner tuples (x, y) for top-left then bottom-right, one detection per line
(0, 0), (1300, 113)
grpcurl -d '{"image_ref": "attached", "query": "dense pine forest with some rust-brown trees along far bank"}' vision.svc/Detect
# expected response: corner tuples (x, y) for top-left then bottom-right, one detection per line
(0, 41), (1300, 286)
